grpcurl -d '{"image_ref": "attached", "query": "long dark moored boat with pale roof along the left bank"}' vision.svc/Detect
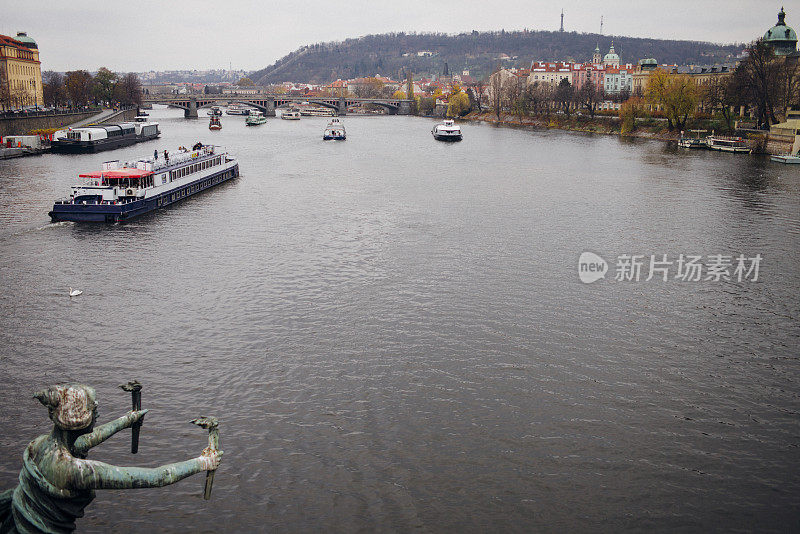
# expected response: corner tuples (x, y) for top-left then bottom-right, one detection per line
(52, 122), (161, 153)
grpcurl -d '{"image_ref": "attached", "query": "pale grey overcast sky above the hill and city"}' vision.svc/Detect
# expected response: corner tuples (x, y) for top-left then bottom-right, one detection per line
(0, 0), (788, 72)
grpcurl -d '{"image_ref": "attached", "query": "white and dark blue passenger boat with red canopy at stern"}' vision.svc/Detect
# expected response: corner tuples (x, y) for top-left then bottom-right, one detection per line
(49, 143), (239, 222)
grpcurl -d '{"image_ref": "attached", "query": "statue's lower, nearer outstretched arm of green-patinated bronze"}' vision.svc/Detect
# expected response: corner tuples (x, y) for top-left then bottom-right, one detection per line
(69, 452), (216, 489)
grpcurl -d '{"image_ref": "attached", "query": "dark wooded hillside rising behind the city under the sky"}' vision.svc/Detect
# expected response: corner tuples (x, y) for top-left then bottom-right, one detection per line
(250, 31), (743, 84)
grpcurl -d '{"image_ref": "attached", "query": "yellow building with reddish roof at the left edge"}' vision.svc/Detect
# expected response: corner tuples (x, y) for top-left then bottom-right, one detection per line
(0, 32), (44, 109)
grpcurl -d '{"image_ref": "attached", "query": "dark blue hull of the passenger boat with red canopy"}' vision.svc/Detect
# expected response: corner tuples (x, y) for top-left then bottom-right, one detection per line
(48, 163), (239, 222)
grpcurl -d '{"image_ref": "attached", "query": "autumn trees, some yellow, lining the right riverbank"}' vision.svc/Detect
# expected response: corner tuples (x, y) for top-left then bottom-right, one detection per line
(467, 40), (800, 133)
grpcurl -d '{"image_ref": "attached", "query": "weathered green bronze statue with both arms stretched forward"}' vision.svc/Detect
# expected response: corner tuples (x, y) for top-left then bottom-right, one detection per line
(0, 383), (222, 534)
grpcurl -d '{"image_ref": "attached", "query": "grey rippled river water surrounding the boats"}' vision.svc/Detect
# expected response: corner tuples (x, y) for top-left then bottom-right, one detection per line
(0, 109), (800, 532)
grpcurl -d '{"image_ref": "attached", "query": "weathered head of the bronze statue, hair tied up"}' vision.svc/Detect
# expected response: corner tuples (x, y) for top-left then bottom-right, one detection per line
(34, 384), (97, 430)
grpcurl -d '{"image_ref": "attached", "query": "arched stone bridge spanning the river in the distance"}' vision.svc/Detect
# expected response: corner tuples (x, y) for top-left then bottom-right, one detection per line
(142, 94), (413, 119)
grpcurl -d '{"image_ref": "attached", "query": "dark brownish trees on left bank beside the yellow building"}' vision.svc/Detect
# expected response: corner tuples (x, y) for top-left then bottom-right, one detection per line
(42, 67), (142, 107)
